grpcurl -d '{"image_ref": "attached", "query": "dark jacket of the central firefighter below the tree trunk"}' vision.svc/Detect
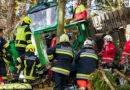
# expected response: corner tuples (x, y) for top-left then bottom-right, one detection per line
(47, 42), (73, 75)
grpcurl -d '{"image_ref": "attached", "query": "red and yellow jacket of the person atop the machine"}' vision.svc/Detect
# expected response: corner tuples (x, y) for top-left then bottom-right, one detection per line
(75, 5), (87, 20)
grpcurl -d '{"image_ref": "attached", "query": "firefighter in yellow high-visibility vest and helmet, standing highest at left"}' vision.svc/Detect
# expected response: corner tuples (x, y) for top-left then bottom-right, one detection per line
(14, 16), (32, 56)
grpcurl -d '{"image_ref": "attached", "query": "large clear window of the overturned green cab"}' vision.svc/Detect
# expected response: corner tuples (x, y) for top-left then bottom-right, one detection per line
(28, 6), (57, 31)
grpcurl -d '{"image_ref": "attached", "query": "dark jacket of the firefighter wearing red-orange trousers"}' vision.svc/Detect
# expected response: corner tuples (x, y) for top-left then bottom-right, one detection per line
(75, 47), (98, 80)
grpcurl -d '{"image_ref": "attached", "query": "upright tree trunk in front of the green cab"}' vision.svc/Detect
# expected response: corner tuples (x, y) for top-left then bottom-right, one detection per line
(56, 0), (66, 43)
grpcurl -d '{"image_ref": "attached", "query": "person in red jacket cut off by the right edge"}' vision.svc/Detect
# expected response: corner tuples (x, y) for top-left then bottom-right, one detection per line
(120, 40), (130, 78)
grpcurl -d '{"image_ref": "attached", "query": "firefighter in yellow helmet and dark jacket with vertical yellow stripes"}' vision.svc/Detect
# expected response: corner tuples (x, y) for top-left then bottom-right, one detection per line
(15, 44), (43, 83)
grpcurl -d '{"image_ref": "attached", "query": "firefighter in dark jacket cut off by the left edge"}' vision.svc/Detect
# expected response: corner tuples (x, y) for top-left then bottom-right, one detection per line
(0, 28), (10, 81)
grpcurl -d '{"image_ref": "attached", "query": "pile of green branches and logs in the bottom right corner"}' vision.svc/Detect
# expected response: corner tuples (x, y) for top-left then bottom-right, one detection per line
(89, 67), (130, 90)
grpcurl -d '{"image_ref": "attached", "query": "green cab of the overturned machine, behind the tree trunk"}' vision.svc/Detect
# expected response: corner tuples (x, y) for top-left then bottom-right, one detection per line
(27, 2), (89, 65)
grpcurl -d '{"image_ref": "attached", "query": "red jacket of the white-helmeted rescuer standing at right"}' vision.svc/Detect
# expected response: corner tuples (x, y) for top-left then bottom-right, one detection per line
(101, 43), (115, 64)
